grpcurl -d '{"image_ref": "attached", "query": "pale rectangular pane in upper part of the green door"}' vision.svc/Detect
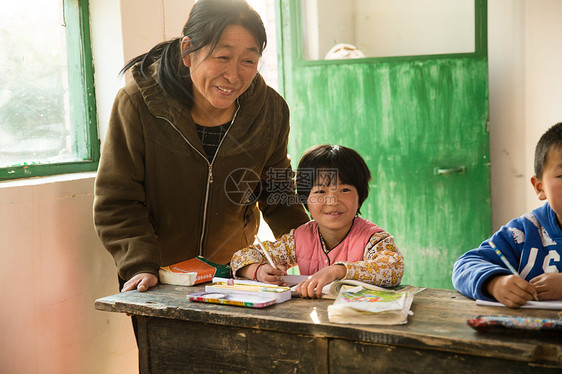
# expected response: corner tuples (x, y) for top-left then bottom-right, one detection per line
(301, 0), (475, 60)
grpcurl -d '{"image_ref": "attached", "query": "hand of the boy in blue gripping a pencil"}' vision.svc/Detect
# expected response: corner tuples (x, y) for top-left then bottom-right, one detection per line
(486, 275), (537, 308)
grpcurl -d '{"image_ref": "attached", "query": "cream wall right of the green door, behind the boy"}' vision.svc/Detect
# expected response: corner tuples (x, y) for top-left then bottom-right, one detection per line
(488, 0), (562, 229)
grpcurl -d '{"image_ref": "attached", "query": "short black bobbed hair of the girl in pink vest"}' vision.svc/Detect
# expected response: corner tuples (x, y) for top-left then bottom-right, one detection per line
(296, 144), (371, 213)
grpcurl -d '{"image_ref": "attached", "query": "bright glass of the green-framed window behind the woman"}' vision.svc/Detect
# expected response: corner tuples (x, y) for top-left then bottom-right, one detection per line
(0, 0), (97, 178)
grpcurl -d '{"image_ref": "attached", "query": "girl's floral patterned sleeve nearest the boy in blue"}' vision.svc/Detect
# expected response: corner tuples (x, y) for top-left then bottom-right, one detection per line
(337, 231), (404, 287)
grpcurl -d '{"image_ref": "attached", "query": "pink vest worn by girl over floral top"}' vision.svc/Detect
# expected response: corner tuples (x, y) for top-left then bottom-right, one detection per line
(294, 217), (383, 275)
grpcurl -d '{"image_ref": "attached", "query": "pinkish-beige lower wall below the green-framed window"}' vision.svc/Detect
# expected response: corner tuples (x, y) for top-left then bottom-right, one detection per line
(0, 173), (137, 374)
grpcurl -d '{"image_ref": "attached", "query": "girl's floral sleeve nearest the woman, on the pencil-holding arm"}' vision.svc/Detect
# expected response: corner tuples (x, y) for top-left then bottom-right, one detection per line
(230, 230), (297, 278)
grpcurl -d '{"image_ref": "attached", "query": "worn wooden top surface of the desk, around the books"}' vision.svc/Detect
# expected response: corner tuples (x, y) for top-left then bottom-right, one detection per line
(96, 285), (562, 367)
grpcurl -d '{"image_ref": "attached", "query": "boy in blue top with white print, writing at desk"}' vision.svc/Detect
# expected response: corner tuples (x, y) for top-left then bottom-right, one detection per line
(453, 122), (562, 308)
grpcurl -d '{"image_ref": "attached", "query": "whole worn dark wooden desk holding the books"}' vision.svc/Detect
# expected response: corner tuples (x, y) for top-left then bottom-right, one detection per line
(96, 285), (562, 374)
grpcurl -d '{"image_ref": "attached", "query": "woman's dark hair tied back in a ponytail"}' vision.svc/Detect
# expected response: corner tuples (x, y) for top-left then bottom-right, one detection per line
(121, 0), (267, 105)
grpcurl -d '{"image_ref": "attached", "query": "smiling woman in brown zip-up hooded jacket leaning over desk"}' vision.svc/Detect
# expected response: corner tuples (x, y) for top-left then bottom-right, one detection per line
(94, 0), (308, 291)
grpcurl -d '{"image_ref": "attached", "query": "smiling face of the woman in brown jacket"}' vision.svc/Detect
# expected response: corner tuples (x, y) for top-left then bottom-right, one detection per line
(181, 25), (260, 113)
